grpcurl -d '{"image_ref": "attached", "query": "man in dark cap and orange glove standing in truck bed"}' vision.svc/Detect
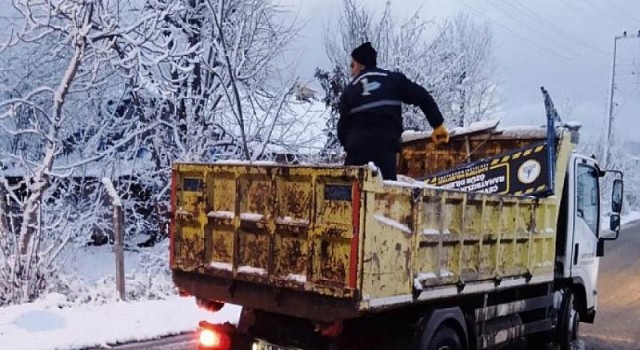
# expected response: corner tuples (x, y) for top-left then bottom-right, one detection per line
(338, 42), (449, 180)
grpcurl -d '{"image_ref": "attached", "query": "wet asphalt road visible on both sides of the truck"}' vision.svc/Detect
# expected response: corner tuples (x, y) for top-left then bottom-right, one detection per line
(94, 222), (640, 350)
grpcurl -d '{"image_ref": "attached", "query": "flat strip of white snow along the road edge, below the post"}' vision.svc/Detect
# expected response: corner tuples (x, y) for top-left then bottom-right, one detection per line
(0, 294), (240, 350)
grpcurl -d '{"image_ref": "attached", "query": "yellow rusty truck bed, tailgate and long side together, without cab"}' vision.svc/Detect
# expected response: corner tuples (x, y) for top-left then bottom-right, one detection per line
(170, 127), (570, 321)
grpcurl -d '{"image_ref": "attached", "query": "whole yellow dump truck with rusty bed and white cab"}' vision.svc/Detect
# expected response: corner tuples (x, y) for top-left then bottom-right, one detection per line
(170, 93), (622, 350)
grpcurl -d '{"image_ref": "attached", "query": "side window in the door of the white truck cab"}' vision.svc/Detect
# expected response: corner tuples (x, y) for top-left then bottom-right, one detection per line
(576, 164), (600, 236)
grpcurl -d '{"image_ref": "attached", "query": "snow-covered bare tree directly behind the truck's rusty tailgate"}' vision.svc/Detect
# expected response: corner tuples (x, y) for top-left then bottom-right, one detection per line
(110, 0), (305, 245)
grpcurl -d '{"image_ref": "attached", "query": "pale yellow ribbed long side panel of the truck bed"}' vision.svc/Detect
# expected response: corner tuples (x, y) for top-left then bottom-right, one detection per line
(361, 174), (558, 309)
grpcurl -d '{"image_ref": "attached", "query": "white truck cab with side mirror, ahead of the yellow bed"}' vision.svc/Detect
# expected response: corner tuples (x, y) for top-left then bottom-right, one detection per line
(556, 154), (623, 324)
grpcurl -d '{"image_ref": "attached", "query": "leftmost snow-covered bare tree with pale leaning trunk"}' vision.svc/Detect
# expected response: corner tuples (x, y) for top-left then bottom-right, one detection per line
(0, 0), (174, 304)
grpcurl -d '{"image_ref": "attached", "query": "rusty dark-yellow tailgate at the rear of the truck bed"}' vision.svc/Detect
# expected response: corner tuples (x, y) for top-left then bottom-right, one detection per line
(175, 164), (365, 297)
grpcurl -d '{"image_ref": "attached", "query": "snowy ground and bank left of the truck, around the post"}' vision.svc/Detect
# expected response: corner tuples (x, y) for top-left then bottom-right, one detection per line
(0, 240), (240, 350)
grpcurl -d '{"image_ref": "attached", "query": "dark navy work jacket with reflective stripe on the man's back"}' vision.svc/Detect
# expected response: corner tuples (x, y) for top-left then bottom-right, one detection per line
(338, 68), (444, 153)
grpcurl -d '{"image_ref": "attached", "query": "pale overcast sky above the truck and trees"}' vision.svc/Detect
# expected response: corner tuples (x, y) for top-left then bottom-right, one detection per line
(281, 0), (640, 141)
